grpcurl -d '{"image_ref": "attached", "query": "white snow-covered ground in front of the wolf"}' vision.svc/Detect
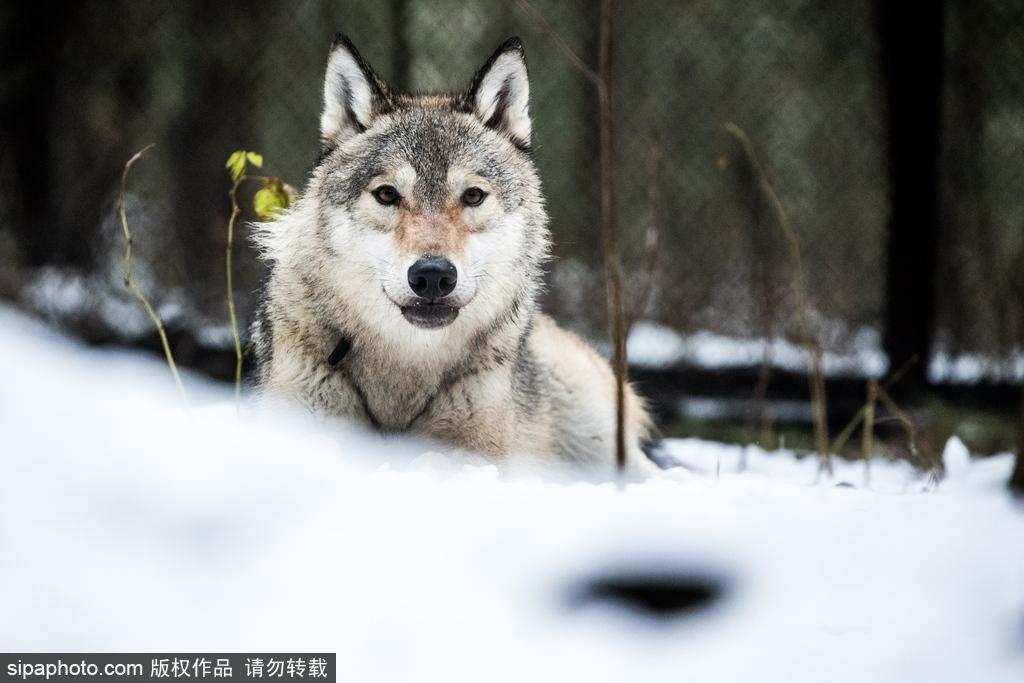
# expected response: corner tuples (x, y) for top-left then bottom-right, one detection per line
(0, 310), (1024, 683)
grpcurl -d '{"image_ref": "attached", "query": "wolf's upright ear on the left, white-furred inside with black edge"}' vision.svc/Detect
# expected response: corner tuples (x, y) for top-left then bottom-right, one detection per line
(321, 34), (388, 146)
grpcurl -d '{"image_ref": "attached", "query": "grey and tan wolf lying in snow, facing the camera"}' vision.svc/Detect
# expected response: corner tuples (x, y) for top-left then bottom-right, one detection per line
(252, 35), (654, 479)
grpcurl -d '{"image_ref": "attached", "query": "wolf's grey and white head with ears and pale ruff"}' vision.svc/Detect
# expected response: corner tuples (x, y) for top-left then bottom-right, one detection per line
(259, 37), (548, 358)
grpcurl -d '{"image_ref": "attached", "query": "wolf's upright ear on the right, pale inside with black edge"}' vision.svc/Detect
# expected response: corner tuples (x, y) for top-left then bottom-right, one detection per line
(468, 38), (530, 146)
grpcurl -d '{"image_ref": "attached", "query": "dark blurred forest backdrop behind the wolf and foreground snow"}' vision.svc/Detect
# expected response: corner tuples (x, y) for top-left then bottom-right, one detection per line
(0, 0), (1024, 464)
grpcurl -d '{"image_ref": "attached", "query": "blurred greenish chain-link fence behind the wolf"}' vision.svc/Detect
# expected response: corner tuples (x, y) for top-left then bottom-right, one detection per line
(0, 0), (1024, 393)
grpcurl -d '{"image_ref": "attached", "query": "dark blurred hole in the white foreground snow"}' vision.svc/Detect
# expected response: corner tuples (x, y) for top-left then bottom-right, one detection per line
(570, 572), (725, 618)
